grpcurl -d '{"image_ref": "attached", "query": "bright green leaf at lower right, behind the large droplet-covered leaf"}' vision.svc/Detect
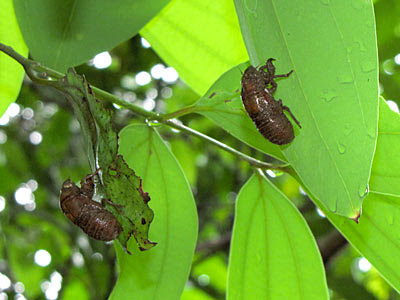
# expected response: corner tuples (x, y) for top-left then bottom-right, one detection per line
(306, 190), (400, 292)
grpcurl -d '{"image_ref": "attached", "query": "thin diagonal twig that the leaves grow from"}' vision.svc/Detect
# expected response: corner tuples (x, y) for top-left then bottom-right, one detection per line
(0, 43), (290, 172)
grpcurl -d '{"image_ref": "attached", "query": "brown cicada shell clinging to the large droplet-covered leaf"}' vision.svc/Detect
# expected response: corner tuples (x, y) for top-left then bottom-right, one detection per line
(241, 60), (297, 145)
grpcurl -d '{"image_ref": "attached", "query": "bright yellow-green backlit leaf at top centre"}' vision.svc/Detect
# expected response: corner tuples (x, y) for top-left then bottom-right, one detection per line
(140, 0), (248, 95)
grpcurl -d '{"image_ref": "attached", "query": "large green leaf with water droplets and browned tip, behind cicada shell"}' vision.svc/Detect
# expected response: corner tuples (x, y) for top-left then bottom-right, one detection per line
(231, 0), (378, 218)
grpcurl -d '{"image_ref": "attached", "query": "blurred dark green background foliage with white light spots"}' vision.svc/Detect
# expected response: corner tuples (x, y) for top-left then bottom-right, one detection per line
(0, 0), (400, 300)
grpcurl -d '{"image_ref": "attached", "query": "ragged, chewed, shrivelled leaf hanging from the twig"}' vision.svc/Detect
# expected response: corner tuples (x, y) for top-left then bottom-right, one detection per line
(54, 69), (156, 252)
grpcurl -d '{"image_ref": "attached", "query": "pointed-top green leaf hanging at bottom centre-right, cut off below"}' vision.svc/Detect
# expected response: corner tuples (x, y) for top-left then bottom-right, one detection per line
(227, 175), (328, 300)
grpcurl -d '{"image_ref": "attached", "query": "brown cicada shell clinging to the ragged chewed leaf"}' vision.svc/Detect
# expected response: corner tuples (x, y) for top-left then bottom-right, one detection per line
(60, 177), (122, 241)
